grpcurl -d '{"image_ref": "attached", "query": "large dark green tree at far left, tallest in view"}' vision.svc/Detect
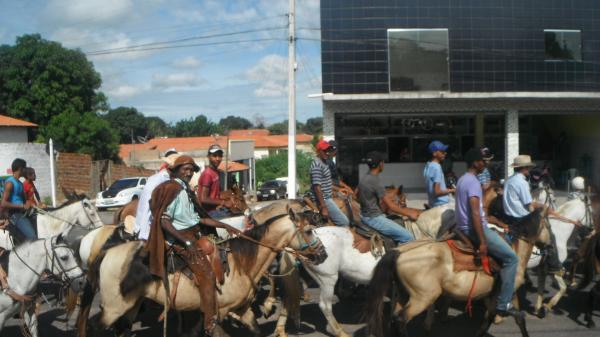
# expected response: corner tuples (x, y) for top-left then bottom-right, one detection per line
(0, 34), (107, 125)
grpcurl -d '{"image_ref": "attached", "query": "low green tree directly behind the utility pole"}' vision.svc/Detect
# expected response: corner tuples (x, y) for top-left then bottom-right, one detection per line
(256, 151), (312, 192)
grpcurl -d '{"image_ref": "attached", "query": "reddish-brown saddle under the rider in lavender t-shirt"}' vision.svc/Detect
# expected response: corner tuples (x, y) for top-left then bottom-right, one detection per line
(446, 230), (500, 275)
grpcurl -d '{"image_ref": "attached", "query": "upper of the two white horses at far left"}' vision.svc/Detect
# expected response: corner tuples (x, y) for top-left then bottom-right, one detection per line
(0, 198), (103, 250)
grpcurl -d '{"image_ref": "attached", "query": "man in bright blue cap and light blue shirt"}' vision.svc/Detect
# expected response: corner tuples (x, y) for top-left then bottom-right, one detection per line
(423, 140), (454, 207)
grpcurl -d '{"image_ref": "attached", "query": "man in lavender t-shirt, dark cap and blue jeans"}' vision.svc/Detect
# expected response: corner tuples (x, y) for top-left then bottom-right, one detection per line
(455, 149), (523, 317)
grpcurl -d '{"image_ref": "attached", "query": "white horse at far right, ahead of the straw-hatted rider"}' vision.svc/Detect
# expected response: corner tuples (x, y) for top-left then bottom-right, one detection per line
(527, 198), (589, 318)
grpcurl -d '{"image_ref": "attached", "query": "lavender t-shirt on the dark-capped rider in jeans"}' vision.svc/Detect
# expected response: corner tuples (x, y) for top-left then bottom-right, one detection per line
(454, 172), (487, 234)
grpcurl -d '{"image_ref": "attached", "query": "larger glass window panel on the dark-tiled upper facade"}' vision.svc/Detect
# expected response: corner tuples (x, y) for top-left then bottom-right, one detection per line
(388, 29), (449, 91)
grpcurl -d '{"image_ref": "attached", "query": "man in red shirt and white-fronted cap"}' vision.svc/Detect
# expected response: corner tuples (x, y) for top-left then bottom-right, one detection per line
(198, 144), (233, 219)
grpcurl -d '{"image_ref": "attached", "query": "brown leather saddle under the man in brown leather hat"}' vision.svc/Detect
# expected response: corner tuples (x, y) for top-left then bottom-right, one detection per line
(167, 236), (229, 284)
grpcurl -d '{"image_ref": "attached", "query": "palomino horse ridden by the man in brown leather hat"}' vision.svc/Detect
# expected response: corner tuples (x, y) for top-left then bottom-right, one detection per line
(88, 201), (324, 333)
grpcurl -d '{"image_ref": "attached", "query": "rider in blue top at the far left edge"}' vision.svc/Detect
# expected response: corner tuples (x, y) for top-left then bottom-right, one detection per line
(0, 158), (37, 240)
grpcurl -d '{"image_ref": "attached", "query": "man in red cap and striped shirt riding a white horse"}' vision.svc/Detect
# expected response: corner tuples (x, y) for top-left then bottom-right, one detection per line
(310, 140), (350, 226)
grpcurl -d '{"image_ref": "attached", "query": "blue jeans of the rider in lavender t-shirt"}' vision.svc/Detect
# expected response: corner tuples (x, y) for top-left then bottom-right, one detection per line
(483, 226), (519, 310)
